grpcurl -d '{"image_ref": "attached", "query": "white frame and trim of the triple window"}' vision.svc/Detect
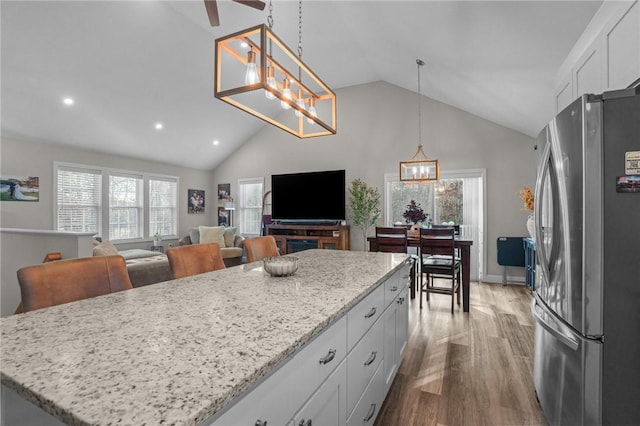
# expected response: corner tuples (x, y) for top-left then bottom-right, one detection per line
(52, 161), (180, 243)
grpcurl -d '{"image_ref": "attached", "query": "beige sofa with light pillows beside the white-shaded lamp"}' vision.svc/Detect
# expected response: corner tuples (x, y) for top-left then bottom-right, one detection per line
(178, 226), (244, 267)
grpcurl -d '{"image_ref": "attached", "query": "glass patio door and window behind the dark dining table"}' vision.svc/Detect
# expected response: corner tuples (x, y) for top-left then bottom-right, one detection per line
(384, 170), (485, 280)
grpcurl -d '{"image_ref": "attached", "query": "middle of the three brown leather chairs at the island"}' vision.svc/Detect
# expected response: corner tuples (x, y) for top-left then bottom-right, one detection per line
(167, 243), (225, 279)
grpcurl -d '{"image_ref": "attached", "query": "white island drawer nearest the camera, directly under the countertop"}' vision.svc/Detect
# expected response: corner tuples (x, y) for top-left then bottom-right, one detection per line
(207, 316), (347, 426)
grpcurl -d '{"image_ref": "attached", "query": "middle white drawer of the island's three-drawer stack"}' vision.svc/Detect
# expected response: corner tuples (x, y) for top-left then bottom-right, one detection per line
(347, 320), (384, 413)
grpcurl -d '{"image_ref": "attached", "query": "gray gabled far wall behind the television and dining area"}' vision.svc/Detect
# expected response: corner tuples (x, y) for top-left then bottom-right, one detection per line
(213, 82), (536, 279)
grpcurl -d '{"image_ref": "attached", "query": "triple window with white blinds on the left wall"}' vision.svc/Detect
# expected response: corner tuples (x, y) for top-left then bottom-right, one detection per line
(54, 163), (178, 241)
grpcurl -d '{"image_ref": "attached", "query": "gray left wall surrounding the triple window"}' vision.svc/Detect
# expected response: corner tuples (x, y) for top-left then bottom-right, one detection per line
(0, 139), (218, 248)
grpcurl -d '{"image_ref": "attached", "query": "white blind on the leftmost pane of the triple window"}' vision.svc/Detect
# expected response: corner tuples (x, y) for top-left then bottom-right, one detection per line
(56, 167), (102, 233)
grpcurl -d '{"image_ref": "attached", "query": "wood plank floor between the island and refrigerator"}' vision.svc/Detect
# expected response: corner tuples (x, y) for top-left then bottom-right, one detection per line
(375, 283), (547, 426)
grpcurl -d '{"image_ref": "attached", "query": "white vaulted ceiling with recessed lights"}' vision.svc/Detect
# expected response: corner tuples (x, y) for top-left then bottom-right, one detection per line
(0, 0), (602, 169)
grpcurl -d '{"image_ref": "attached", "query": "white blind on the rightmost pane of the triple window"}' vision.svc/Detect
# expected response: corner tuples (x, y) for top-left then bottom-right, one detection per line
(148, 178), (178, 237)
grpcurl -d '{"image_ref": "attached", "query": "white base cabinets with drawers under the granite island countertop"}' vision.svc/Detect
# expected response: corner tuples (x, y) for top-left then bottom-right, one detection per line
(207, 263), (411, 426)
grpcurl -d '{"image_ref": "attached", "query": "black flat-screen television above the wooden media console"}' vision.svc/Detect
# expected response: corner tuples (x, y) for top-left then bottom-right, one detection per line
(271, 170), (346, 223)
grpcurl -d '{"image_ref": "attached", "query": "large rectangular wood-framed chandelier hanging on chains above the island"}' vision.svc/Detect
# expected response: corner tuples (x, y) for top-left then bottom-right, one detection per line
(214, 0), (337, 138)
